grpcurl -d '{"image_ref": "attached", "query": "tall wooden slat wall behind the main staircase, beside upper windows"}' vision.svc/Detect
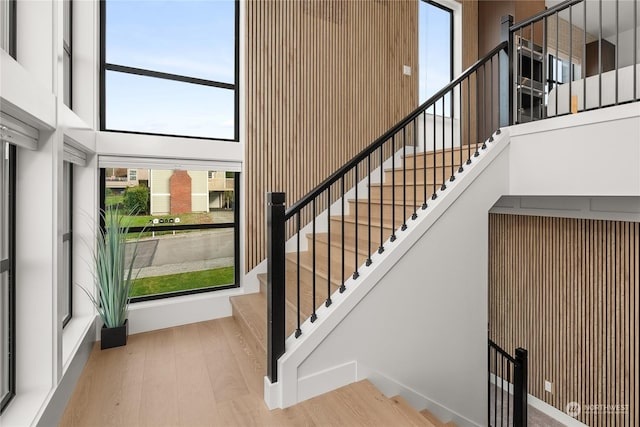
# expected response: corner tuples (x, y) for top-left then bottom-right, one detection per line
(245, 0), (478, 271)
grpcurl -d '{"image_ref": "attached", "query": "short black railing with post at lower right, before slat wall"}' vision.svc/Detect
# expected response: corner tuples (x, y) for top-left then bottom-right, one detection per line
(487, 340), (528, 427)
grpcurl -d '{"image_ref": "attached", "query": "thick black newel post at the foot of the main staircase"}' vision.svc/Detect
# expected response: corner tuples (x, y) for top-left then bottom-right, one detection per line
(267, 193), (286, 383)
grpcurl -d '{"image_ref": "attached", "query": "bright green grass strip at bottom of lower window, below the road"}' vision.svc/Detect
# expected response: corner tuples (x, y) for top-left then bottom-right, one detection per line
(131, 266), (234, 297)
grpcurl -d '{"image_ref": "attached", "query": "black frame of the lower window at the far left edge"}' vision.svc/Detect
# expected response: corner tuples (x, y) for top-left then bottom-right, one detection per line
(0, 141), (17, 414)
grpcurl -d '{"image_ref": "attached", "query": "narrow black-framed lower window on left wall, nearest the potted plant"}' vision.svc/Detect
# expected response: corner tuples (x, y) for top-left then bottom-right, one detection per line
(62, 162), (73, 327)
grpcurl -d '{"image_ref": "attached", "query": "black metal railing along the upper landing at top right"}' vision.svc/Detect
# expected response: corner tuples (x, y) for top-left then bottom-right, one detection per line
(509, 0), (640, 123)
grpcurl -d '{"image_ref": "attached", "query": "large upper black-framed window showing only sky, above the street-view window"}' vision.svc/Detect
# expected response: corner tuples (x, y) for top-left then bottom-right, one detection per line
(101, 0), (239, 140)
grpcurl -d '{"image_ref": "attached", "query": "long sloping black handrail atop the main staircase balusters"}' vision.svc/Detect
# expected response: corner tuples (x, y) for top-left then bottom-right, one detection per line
(285, 41), (509, 219)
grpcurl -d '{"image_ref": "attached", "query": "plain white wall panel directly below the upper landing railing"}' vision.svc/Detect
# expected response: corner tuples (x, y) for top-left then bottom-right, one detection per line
(509, 102), (640, 196)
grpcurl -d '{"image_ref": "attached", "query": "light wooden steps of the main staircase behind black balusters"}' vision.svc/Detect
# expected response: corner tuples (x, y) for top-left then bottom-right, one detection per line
(231, 146), (475, 425)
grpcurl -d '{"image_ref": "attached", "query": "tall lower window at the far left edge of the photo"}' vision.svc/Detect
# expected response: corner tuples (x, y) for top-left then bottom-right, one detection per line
(0, 140), (16, 412)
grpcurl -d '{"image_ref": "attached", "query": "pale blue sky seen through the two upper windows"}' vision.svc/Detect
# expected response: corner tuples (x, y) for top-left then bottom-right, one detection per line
(106, 0), (451, 139)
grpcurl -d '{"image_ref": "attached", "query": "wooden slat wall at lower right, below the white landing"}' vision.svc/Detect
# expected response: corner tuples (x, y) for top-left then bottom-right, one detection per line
(489, 214), (640, 426)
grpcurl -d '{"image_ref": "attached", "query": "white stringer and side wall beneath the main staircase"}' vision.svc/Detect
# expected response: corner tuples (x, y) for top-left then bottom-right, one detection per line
(265, 129), (510, 425)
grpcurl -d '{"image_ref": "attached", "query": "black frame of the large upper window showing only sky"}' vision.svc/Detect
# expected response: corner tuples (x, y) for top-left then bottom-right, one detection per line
(100, 0), (240, 142)
